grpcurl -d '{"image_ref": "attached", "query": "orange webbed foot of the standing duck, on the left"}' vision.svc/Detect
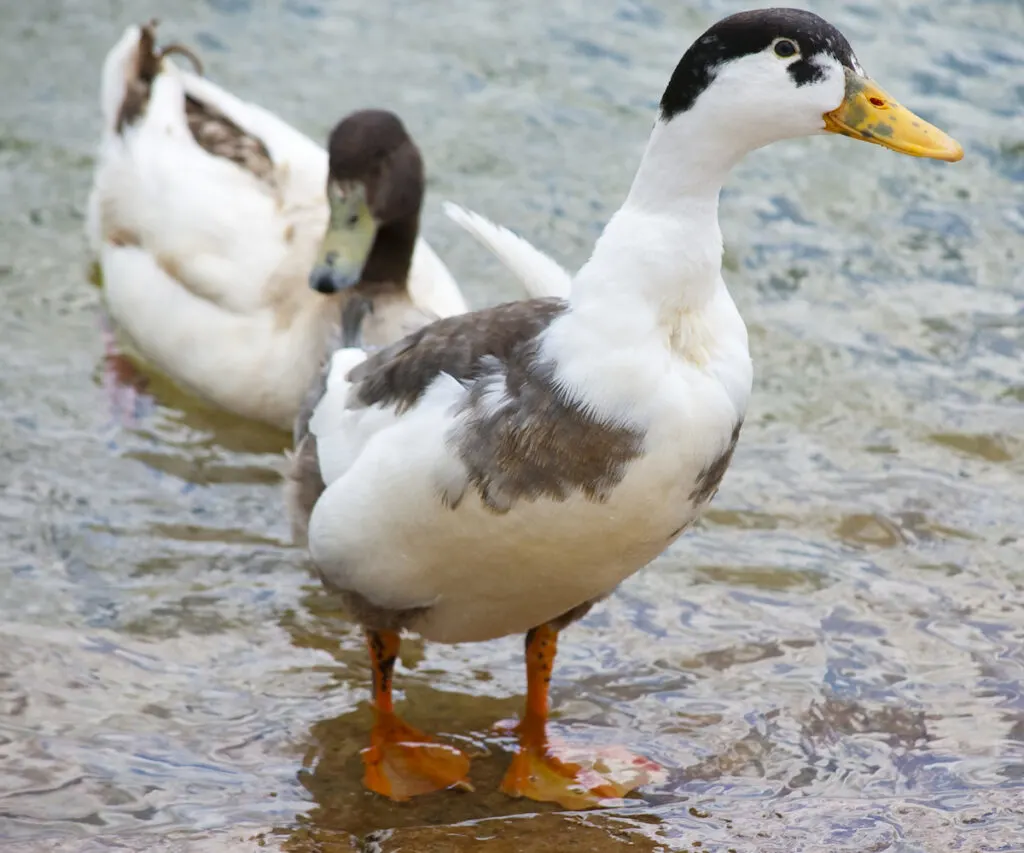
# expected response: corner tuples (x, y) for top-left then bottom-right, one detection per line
(361, 714), (473, 802)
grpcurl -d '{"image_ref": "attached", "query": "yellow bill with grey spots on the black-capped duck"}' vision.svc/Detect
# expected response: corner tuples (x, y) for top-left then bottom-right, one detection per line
(824, 69), (964, 163)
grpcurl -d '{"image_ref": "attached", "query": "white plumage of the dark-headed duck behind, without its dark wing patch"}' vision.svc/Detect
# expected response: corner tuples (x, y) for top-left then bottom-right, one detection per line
(87, 27), (564, 429)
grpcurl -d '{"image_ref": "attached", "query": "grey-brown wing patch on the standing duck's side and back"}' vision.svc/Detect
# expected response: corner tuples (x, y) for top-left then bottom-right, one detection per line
(348, 299), (644, 512)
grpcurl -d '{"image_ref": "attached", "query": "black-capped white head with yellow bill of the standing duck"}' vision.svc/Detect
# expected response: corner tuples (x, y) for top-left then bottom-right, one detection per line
(659, 8), (964, 161)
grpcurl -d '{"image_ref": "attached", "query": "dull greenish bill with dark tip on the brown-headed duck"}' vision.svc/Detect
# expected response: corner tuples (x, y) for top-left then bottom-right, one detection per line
(309, 181), (378, 293)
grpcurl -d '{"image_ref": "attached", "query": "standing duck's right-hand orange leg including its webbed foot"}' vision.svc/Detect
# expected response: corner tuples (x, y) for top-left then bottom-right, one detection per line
(502, 625), (660, 809)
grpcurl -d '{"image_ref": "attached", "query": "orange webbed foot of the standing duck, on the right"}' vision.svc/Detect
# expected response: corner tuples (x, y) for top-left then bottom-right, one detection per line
(502, 742), (660, 809)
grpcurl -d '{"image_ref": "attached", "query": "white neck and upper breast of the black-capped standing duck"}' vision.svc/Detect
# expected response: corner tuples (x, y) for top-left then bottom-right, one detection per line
(542, 110), (749, 422)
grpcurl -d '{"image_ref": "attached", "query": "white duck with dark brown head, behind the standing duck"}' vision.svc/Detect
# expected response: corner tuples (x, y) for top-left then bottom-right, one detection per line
(86, 20), (560, 430)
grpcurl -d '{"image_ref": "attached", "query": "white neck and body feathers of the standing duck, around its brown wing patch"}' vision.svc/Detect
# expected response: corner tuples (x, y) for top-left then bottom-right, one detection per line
(309, 106), (752, 642)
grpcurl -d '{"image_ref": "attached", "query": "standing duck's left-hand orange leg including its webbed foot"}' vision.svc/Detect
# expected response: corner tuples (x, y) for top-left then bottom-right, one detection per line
(361, 631), (473, 802)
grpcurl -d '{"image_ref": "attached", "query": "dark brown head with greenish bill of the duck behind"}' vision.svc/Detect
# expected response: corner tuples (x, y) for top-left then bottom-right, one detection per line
(309, 110), (425, 293)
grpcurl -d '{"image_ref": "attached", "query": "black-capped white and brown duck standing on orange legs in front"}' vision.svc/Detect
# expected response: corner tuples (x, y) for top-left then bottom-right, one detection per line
(299, 8), (964, 808)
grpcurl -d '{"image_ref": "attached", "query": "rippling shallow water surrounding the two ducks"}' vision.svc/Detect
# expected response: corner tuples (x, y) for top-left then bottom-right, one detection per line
(0, 0), (1024, 853)
